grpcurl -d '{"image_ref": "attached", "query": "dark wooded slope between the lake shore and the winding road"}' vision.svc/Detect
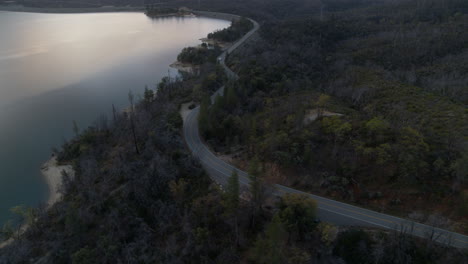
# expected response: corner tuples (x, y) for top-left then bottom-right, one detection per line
(0, 46), (467, 264)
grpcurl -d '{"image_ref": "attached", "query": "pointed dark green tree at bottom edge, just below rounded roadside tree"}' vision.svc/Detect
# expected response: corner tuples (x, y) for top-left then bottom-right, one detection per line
(251, 214), (286, 264)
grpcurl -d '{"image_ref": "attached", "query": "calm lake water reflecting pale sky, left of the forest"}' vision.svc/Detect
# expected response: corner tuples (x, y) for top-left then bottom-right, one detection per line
(0, 12), (229, 226)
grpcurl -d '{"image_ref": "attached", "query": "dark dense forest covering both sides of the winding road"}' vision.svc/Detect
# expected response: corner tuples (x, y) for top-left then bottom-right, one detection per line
(0, 0), (468, 264)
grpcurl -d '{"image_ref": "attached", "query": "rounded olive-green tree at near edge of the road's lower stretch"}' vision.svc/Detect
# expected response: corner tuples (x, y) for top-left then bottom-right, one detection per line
(279, 193), (317, 239)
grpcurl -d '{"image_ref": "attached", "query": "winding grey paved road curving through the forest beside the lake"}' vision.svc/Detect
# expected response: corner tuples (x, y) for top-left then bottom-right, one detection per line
(183, 14), (468, 248)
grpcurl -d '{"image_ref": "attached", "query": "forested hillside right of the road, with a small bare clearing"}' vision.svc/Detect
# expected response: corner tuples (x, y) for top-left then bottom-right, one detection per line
(197, 1), (468, 232)
